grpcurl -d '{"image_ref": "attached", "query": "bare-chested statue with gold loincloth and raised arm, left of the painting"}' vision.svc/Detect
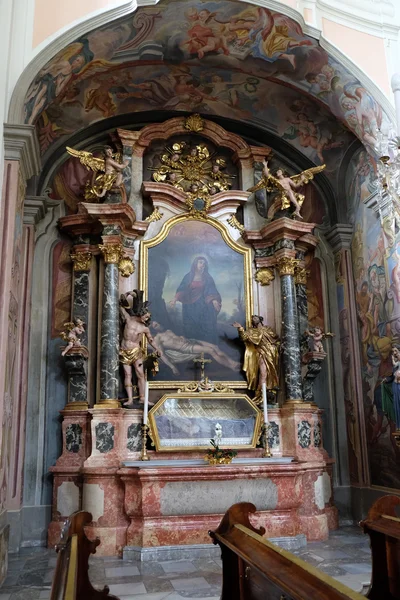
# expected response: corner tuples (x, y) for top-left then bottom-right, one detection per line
(119, 290), (161, 406)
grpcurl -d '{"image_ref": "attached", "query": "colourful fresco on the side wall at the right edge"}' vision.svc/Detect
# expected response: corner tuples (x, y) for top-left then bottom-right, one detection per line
(352, 204), (400, 489)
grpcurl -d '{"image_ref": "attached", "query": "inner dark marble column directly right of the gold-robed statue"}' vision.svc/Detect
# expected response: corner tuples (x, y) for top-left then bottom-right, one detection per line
(277, 256), (302, 402)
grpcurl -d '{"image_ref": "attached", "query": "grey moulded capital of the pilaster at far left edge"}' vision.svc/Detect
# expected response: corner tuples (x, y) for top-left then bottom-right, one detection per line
(4, 123), (41, 181)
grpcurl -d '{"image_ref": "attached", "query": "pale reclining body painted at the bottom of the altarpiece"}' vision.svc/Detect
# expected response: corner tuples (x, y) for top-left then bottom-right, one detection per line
(151, 321), (240, 375)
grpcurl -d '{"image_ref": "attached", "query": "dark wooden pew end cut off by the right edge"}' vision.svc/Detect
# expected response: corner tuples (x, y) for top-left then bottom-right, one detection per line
(360, 496), (400, 600)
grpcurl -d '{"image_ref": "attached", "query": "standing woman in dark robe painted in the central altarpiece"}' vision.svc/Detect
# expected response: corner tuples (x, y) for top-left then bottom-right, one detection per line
(169, 256), (222, 345)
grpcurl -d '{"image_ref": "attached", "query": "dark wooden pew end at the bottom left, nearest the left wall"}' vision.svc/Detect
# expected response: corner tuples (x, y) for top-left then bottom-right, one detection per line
(50, 511), (118, 600)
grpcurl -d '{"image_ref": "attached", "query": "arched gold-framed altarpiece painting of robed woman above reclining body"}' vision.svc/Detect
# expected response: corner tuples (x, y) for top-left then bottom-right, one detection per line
(141, 215), (252, 388)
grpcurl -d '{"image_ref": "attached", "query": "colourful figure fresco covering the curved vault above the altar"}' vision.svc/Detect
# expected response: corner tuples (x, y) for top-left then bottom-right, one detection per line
(25, 0), (388, 166)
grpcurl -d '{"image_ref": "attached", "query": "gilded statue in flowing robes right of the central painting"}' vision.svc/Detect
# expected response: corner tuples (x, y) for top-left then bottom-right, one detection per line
(233, 315), (280, 390)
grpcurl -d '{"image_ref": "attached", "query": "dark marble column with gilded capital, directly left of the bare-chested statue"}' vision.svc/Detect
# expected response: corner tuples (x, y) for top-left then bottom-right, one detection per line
(98, 243), (122, 408)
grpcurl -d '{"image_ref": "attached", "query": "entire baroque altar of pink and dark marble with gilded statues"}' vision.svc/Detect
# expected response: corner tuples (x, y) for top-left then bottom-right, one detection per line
(49, 115), (337, 560)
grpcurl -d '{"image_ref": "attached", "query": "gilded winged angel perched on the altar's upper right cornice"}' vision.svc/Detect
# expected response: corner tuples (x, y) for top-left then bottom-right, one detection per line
(247, 160), (326, 219)
